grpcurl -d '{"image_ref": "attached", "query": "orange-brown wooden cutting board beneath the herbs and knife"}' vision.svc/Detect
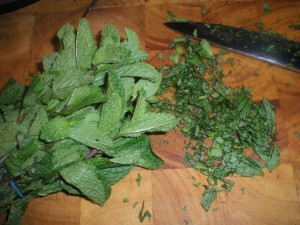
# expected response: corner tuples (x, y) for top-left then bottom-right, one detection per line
(0, 0), (300, 225)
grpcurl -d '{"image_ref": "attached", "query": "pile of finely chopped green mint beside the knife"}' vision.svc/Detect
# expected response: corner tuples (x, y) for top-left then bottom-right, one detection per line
(155, 37), (280, 210)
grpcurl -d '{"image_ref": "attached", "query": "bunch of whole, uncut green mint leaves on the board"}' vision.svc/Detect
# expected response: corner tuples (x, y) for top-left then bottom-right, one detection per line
(0, 19), (178, 225)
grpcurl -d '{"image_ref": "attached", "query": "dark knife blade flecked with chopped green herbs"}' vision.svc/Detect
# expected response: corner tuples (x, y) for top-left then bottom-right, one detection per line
(165, 22), (300, 73)
